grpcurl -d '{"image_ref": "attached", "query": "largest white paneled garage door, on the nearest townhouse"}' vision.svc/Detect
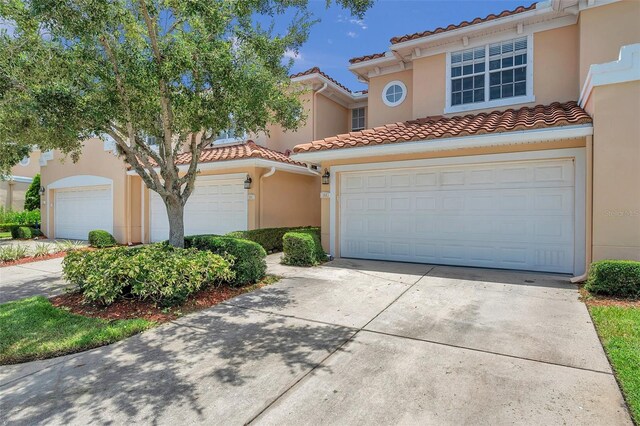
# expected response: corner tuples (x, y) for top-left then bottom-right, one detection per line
(340, 160), (574, 273)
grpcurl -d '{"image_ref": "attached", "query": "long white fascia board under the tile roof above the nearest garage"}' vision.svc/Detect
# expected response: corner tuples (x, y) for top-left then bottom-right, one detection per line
(291, 124), (593, 163)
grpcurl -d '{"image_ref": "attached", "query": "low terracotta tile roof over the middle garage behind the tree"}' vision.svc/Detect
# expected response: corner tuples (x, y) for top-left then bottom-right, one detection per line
(176, 141), (305, 167)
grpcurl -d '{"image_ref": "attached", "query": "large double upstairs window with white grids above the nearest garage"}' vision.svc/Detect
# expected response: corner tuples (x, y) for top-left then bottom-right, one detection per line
(445, 37), (534, 112)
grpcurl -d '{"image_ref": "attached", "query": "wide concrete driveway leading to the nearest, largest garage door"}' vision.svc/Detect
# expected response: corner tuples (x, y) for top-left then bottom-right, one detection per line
(0, 256), (631, 425)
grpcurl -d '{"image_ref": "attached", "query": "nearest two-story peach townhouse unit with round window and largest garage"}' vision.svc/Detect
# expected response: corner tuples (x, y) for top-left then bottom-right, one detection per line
(291, 0), (640, 276)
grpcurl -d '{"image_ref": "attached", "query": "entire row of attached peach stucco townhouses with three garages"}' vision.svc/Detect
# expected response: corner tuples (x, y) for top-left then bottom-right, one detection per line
(42, 0), (640, 276)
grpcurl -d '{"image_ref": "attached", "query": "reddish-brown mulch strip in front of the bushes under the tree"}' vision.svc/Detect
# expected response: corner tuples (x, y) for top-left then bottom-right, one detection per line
(50, 282), (268, 323)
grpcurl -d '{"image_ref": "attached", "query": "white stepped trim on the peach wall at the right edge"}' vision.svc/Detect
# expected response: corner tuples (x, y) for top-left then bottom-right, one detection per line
(578, 43), (640, 108)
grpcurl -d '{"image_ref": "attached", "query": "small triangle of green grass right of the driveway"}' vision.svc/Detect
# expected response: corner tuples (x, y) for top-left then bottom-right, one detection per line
(589, 306), (640, 424)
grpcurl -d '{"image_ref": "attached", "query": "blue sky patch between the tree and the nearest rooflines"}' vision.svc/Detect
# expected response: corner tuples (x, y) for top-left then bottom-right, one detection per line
(284, 0), (533, 90)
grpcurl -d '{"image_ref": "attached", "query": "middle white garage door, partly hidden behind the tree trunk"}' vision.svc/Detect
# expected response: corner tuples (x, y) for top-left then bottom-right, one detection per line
(150, 176), (247, 241)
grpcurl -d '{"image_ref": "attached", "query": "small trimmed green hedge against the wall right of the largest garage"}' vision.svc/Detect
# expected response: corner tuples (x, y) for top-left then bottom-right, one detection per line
(585, 260), (640, 298)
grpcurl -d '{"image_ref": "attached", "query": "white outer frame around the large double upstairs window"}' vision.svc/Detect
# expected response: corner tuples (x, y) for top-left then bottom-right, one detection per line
(444, 34), (536, 114)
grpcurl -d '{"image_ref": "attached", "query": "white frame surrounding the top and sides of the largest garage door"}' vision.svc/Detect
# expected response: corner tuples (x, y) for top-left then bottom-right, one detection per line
(329, 148), (587, 276)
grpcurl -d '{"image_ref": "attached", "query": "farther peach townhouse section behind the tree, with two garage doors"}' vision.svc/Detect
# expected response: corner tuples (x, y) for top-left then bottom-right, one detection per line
(41, 68), (367, 244)
